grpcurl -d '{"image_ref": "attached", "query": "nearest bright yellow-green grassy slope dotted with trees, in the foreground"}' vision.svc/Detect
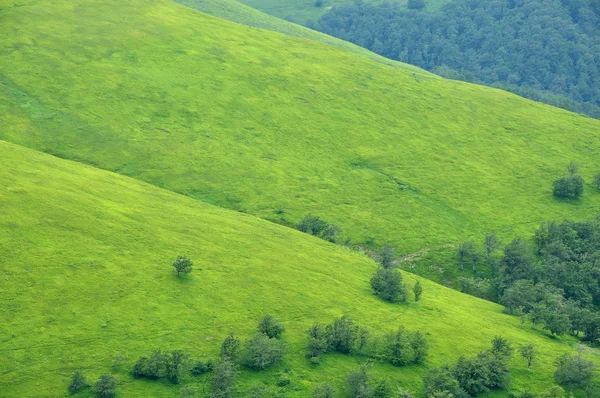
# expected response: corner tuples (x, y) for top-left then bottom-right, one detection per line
(0, 141), (598, 397)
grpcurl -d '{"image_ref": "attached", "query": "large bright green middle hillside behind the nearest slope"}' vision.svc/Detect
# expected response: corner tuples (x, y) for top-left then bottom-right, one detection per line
(0, 0), (600, 268)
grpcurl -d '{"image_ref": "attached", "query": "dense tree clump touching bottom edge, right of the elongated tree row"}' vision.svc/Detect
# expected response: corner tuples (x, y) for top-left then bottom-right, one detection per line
(423, 336), (513, 397)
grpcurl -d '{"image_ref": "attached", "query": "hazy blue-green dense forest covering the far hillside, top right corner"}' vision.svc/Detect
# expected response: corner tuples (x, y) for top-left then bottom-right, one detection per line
(313, 0), (600, 118)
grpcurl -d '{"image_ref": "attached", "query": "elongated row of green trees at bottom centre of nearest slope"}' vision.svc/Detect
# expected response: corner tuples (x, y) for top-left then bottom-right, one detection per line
(306, 316), (429, 366)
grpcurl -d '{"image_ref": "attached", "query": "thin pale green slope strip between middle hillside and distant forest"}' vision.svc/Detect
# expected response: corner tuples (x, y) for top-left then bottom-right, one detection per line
(175, 0), (433, 77)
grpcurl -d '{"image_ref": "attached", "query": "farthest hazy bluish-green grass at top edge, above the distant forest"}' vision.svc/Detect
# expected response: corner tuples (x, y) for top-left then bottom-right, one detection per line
(232, 0), (450, 25)
